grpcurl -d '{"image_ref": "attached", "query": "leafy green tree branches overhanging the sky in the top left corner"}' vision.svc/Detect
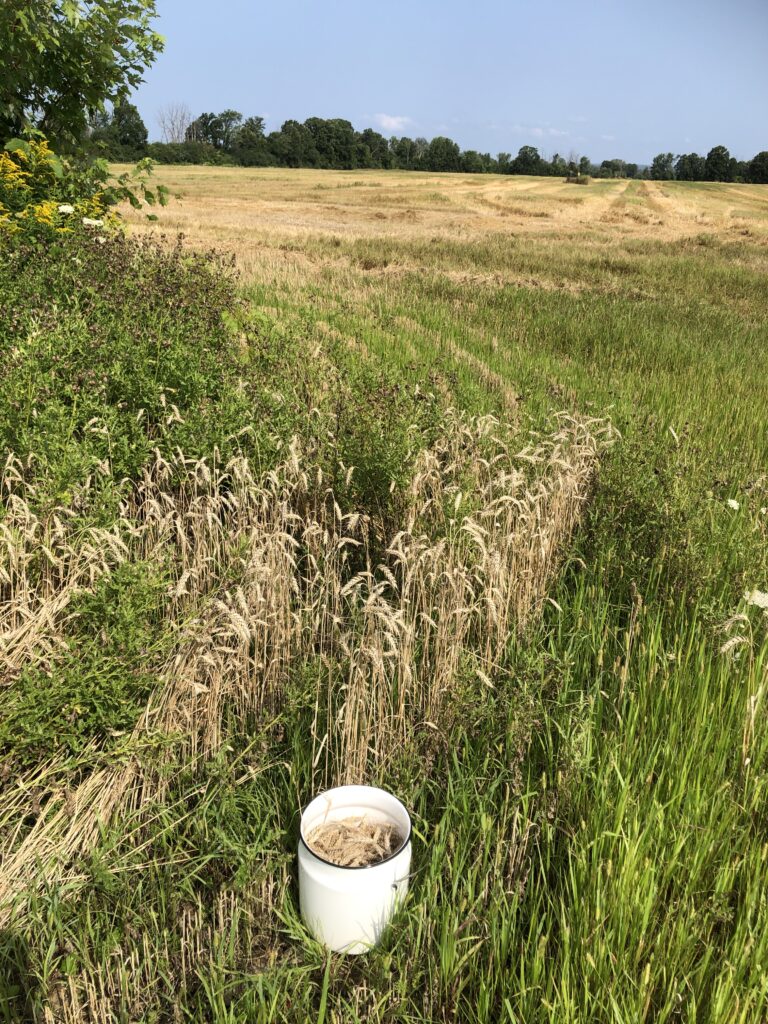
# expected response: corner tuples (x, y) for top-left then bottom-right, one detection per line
(0, 0), (163, 142)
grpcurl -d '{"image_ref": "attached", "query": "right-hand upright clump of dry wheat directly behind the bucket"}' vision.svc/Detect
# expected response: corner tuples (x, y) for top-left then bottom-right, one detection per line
(315, 417), (610, 784)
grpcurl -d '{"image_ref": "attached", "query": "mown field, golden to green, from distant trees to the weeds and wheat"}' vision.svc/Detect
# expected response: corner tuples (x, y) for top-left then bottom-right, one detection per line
(120, 167), (768, 484)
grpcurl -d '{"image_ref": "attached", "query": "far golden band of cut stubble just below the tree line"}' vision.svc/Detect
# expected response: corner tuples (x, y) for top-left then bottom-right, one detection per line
(121, 167), (768, 249)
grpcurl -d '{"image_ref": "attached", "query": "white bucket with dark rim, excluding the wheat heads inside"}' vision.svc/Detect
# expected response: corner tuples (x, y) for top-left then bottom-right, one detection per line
(299, 785), (411, 953)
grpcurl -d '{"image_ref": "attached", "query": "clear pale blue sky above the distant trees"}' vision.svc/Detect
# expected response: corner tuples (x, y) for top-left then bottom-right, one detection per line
(134, 0), (768, 163)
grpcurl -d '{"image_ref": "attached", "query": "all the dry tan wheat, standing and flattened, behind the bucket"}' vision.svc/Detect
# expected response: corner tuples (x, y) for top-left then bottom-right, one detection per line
(0, 414), (612, 924)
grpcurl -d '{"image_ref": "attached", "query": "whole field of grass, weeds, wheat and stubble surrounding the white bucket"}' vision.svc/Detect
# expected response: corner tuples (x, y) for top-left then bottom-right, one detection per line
(0, 167), (768, 1024)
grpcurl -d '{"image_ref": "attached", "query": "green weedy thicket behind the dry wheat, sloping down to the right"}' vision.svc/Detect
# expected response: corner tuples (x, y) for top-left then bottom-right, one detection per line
(0, 225), (439, 523)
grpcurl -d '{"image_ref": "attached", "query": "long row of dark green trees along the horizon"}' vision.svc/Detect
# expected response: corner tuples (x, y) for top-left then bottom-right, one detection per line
(90, 100), (768, 183)
